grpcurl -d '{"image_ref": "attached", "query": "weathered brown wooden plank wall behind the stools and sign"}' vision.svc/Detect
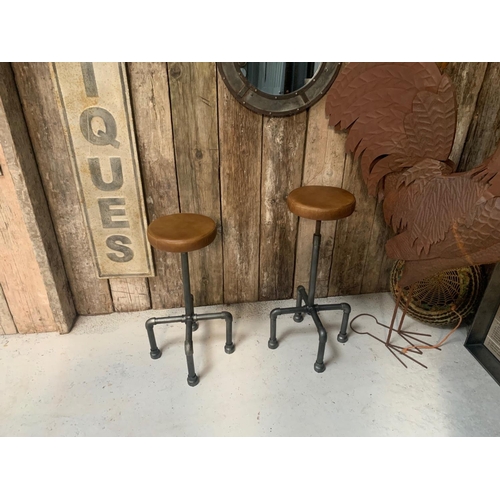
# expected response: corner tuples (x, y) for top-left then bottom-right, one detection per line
(6, 63), (500, 322)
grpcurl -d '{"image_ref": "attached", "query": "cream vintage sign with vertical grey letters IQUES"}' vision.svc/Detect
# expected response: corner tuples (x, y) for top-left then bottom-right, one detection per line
(51, 63), (154, 278)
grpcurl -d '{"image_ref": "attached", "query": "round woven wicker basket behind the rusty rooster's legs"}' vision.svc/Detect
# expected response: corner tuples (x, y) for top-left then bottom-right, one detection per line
(390, 260), (484, 326)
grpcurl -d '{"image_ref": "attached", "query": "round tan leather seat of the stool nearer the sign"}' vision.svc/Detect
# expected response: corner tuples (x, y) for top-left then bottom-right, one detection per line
(148, 214), (217, 252)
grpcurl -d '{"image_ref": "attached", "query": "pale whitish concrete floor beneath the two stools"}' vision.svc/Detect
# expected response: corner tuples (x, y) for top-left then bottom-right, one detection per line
(0, 294), (500, 436)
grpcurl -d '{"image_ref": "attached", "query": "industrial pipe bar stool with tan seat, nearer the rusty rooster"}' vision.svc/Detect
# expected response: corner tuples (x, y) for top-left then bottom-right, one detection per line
(268, 186), (356, 373)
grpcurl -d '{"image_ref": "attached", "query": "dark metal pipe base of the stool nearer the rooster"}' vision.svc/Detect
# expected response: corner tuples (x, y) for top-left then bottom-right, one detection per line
(267, 221), (351, 373)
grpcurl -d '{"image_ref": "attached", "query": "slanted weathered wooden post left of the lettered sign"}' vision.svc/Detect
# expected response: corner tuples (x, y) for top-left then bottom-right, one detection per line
(0, 63), (76, 333)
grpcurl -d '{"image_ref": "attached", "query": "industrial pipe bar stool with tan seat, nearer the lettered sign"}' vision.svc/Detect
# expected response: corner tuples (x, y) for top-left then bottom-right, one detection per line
(146, 214), (234, 387)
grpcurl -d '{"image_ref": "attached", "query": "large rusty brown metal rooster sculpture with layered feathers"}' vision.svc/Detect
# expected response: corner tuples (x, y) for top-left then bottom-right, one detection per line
(326, 63), (500, 368)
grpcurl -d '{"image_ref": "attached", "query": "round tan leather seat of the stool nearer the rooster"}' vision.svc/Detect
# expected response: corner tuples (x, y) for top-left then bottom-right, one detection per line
(286, 186), (356, 220)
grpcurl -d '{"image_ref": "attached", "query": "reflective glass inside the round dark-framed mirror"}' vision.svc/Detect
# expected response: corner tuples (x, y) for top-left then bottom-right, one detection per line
(238, 62), (322, 95)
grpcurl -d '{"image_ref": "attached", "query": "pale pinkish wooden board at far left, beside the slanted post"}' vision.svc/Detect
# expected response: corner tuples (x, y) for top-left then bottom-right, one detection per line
(0, 145), (56, 333)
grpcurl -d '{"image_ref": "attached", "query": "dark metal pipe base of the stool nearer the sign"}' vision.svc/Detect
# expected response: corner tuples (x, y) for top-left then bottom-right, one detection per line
(146, 253), (234, 387)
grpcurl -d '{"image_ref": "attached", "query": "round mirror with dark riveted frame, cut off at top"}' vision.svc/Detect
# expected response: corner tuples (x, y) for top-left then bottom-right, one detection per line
(217, 62), (340, 116)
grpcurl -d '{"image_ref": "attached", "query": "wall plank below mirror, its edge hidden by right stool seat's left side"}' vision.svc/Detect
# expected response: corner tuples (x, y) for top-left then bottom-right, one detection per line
(259, 112), (307, 300)
